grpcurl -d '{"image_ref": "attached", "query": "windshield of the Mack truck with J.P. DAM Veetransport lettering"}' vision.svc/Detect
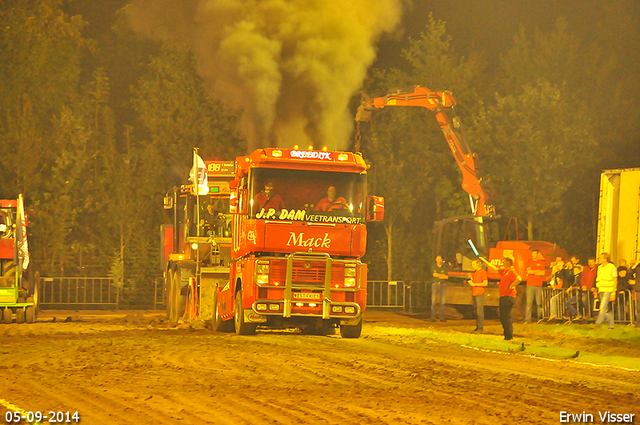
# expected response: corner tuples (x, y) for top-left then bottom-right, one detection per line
(249, 168), (366, 224)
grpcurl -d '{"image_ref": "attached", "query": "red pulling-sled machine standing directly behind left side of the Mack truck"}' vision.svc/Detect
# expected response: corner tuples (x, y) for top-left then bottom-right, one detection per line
(161, 161), (235, 322)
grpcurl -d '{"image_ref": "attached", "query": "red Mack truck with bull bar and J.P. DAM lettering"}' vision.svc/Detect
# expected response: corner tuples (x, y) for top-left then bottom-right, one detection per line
(165, 148), (384, 338)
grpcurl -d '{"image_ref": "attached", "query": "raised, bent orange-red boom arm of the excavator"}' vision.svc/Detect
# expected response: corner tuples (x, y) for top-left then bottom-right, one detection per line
(356, 86), (494, 216)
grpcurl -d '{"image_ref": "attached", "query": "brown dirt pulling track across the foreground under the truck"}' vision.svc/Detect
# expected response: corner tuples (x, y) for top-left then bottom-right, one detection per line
(0, 313), (640, 425)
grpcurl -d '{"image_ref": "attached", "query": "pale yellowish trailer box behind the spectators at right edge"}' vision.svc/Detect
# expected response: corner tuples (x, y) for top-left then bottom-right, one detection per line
(597, 168), (640, 265)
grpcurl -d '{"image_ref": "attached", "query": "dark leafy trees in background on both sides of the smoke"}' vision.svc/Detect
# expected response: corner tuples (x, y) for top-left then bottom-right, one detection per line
(0, 0), (640, 303)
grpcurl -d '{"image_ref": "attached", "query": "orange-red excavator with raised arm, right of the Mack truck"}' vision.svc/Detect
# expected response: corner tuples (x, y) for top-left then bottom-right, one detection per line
(356, 86), (568, 305)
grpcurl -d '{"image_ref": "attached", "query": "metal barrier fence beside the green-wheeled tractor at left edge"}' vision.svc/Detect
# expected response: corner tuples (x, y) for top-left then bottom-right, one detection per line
(39, 277), (120, 309)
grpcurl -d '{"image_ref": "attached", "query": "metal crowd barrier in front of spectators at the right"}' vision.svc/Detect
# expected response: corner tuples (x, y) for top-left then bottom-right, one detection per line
(542, 287), (635, 323)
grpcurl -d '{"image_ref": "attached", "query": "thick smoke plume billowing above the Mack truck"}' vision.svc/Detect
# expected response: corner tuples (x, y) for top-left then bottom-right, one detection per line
(128, 0), (403, 148)
